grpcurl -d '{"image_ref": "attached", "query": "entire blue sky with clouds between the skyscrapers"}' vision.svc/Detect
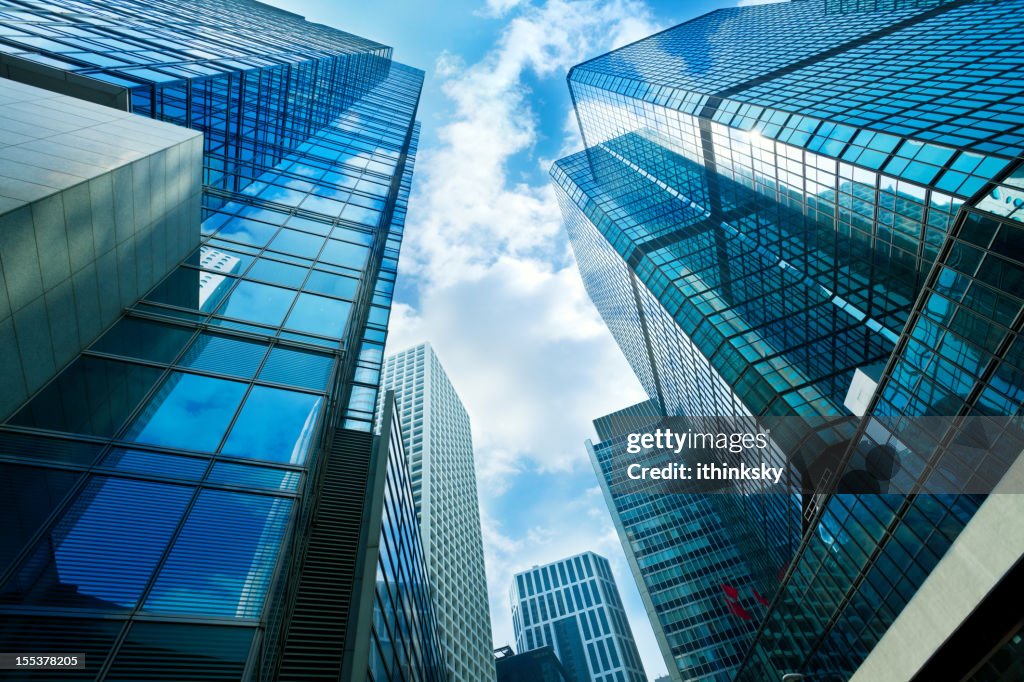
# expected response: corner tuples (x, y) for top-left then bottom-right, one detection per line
(272, 0), (749, 679)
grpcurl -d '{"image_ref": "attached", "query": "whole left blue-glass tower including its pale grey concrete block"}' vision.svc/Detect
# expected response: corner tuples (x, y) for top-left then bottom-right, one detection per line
(0, 0), (445, 682)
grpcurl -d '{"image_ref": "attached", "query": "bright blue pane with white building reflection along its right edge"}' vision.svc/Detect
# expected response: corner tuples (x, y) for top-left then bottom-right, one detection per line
(221, 386), (322, 464)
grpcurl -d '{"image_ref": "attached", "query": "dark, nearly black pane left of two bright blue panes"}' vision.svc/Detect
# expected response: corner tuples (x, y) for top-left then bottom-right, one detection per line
(10, 356), (161, 436)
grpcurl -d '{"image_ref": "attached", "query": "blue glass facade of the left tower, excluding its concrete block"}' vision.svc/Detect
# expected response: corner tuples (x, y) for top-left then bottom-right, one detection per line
(0, 0), (443, 680)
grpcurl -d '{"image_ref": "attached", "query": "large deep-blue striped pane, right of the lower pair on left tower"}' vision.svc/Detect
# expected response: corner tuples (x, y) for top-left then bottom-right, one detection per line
(145, 491), (292, 617)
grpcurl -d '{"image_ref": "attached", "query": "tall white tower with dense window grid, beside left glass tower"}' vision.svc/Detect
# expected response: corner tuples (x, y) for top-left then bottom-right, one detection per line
(381, 343), (495, 682)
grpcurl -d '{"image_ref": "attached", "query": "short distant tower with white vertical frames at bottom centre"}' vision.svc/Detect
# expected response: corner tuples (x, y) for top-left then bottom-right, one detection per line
(509, 552), (647, 682)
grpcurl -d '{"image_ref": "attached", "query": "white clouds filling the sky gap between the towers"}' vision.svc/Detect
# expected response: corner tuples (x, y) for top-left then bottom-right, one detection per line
(388, 0), (662, 671)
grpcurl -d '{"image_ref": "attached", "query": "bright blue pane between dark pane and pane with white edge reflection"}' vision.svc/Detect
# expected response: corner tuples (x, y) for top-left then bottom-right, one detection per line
(125, 372), (246, 452)
